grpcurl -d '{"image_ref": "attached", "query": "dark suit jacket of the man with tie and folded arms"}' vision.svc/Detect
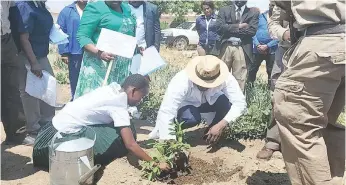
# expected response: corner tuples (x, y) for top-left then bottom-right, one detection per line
(212, 4), (260, 62)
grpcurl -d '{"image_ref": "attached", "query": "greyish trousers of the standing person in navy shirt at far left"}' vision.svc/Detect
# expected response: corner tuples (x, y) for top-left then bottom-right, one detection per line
(19, 53), (55, 132)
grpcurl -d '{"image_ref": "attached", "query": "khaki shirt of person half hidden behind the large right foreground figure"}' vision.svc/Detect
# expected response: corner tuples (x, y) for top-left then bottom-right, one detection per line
(268, 6), (291, 48)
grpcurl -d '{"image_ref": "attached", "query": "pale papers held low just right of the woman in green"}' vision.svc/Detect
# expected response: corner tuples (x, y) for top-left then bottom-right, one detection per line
(130, 46), (166, 75)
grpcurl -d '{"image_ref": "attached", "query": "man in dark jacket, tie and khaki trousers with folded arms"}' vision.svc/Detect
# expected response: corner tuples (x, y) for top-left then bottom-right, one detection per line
(212, 1), (259, 91)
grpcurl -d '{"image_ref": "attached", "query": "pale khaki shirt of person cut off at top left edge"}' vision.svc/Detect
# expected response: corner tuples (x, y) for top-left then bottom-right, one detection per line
(0, 1), (15, 35)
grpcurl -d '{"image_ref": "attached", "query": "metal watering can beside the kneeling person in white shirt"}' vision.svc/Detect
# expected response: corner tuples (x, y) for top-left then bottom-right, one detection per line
(49, 127), (101, 185)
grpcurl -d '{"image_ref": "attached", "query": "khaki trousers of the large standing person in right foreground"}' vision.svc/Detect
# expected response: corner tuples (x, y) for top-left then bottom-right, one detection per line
(274, 34), (346, 185)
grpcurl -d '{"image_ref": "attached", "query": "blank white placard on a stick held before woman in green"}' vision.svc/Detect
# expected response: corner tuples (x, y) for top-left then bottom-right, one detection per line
(96, 28), (137, 58)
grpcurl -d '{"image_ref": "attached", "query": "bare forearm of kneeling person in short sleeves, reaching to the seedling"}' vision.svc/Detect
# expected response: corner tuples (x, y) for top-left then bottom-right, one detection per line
(120, 127), (152, 161)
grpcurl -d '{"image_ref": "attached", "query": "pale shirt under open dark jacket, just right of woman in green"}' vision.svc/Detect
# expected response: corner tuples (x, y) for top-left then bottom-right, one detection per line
(130, 5), (147, 48)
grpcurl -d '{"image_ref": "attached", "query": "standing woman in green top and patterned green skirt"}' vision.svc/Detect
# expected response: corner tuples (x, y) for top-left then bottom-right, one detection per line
(74, 1), (136, 98)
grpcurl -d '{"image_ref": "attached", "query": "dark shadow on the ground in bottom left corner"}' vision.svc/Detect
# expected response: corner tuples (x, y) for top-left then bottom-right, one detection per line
(1, 144), (39, 181)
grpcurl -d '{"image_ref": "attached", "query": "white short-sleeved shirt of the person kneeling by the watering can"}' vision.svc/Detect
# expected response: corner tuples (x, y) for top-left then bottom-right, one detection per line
(52, 83), (130, 132)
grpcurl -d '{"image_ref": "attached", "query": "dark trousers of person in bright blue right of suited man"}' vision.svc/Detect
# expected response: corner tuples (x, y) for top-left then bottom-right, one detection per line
(248, 53), (275, 85)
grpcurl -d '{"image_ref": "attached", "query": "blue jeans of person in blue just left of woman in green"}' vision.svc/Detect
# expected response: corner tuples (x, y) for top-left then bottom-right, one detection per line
(68, 54), (83, 101)
